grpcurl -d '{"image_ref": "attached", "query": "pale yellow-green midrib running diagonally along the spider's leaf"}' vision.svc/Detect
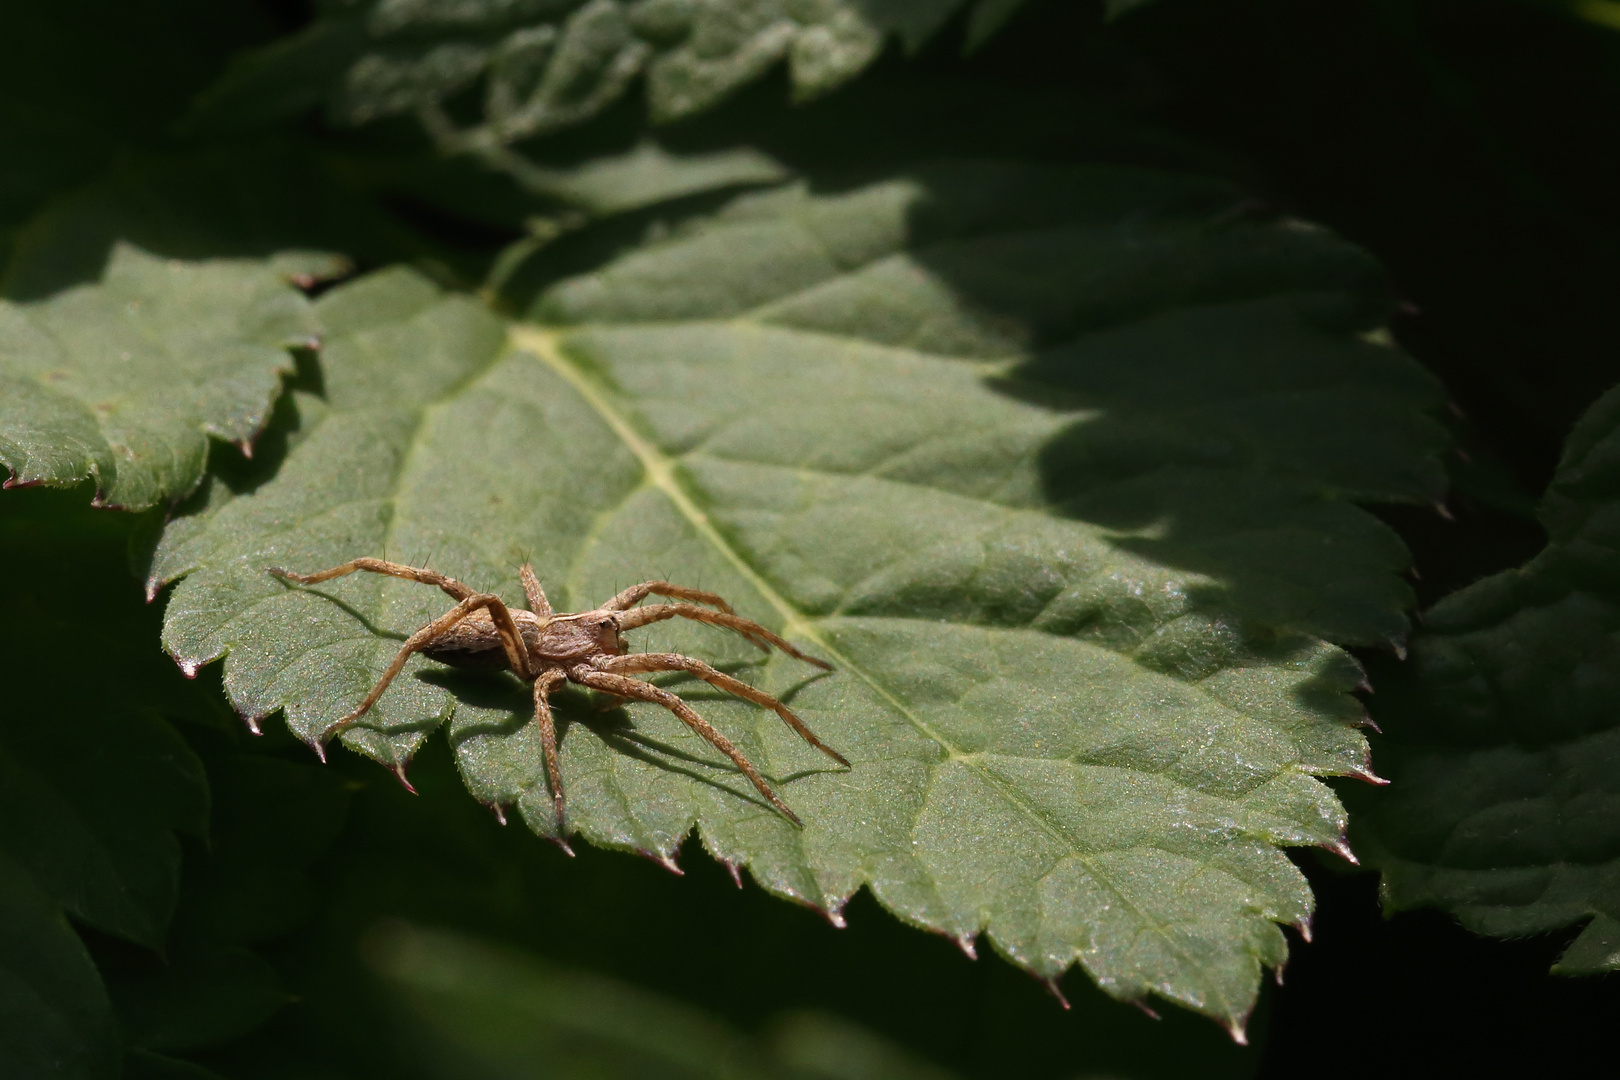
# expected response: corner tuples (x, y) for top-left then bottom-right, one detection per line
(507, 324), (1230, 1012)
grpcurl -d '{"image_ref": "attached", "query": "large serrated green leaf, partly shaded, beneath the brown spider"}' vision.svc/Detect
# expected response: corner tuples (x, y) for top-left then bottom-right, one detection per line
(152, 165), (1445, 1033)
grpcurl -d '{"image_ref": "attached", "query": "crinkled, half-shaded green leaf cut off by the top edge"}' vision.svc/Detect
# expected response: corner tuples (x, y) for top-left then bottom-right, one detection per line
(191, 0), (1006, 144)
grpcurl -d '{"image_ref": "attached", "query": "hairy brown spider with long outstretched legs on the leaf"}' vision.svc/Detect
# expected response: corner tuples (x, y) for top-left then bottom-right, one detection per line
(269, 559), (851, 836)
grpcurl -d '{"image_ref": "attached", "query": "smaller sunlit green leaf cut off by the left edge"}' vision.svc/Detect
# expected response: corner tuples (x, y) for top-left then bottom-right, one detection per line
(0, 244), (335, 508)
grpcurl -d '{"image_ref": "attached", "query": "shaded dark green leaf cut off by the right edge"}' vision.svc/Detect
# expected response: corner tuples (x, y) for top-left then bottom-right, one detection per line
(1358, 382), (1620, 975)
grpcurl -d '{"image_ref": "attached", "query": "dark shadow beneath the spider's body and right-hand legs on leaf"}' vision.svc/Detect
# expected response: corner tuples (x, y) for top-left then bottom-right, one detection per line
(416, 667), (826, 813)
